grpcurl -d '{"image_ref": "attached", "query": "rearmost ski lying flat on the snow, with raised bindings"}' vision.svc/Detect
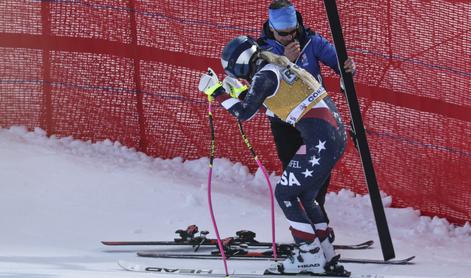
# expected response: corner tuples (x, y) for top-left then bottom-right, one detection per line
(101, 225), (374, 251)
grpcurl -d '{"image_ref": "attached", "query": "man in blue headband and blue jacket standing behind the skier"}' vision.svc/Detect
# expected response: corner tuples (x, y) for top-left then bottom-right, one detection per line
(257, 0), (355, 224)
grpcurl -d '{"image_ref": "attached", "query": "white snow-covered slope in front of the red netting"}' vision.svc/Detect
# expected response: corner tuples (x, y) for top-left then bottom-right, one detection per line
(0, 127), (471, 278)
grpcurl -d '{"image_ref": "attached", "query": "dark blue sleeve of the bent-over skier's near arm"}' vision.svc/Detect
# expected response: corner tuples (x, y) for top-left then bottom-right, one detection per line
(227, 70), (278, 121)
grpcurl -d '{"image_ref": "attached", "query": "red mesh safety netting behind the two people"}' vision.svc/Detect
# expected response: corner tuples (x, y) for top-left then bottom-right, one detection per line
(0, 0), (471, 224)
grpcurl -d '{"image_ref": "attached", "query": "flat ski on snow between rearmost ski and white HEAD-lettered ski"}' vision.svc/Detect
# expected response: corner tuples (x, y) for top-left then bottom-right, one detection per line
(137, 251), (415, 265)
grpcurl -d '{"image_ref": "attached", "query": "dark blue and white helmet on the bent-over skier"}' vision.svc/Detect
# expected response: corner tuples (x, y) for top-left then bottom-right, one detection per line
(221, 36), (259, 79)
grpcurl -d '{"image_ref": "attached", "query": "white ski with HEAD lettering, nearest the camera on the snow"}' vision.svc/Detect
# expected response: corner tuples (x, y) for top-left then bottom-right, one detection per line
(118, 260), (413, 278)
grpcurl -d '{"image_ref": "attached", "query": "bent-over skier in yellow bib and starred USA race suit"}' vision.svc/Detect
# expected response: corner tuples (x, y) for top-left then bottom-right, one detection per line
(199, 36), (348, 276)
